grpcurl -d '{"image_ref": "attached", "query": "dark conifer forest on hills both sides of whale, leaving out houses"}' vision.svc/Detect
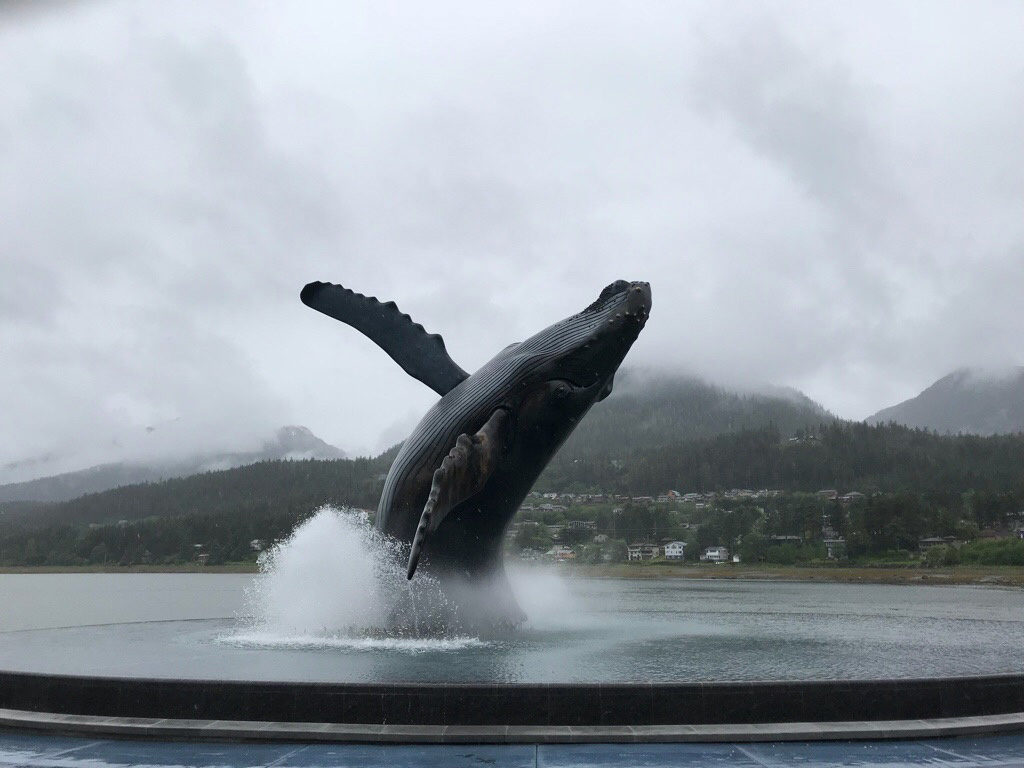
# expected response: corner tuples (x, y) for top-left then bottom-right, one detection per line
(0, 422), (1024, 565)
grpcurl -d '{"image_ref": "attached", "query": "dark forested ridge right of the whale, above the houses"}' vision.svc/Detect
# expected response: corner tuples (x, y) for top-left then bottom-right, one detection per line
(538, 422), (1024, 512)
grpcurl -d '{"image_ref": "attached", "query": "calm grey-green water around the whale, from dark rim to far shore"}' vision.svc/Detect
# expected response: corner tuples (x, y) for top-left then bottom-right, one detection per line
(0, 571), (1024, 682)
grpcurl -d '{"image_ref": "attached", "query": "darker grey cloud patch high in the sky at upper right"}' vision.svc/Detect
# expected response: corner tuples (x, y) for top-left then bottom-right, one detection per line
(693, 17), (897, 227)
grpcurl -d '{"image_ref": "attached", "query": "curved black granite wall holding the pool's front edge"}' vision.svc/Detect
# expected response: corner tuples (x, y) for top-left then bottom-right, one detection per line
(0, 672), (1024, 726)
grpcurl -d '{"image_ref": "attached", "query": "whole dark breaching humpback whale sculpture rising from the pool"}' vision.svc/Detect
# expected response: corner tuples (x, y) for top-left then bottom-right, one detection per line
(300, 281), (651, 630)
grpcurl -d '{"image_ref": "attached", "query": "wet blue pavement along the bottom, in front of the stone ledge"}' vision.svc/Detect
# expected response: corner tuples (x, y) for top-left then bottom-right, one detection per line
(6, 731), (1024, 768)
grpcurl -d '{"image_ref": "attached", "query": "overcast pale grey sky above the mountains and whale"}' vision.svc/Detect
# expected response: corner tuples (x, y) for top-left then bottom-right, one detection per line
(0, 0), (1024, 481)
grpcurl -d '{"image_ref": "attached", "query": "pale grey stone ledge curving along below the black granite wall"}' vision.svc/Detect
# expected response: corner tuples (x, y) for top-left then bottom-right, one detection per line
(0, 709), (1024, 744)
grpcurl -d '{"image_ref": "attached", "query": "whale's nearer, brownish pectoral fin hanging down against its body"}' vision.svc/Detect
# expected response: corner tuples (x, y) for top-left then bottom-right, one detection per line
(407, 409), (509, 579)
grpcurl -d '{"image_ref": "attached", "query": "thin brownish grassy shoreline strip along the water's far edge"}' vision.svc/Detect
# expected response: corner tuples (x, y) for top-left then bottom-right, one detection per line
(0, 562), (1024, 589)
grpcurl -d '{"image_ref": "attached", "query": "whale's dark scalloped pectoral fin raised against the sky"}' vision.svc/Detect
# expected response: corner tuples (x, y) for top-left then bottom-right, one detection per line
(299, 283), (469, 396)
